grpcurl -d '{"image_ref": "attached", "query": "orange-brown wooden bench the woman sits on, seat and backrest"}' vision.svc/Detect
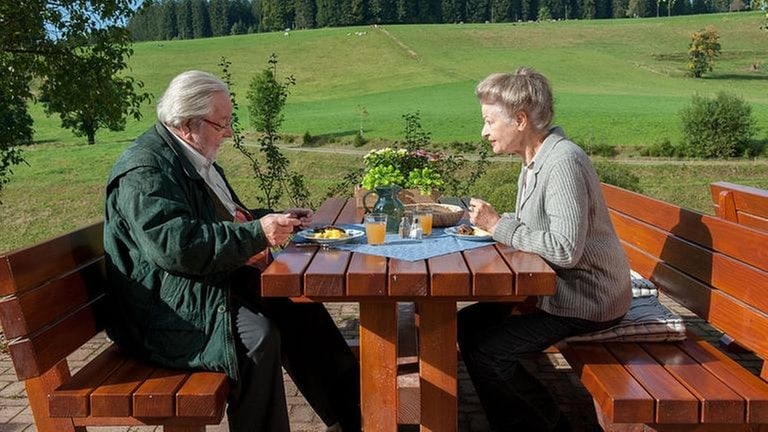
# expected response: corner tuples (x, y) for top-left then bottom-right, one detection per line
(559, 185), (768, 432)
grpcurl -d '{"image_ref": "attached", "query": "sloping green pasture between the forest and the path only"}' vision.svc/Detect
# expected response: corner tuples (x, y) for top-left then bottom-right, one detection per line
(27, 13), (768, 147)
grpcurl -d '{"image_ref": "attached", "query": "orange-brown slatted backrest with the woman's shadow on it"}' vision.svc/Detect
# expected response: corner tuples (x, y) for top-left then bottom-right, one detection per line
(603, 184), (768, 359)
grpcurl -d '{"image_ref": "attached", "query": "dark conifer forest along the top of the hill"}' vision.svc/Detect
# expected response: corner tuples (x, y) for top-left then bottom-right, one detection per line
(128, 0), (749, 41)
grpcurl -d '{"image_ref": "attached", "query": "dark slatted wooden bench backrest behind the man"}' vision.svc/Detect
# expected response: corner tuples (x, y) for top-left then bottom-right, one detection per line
(0, 222), (106, 380)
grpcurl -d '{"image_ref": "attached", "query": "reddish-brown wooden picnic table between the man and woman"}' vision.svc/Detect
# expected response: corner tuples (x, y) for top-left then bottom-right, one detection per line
(261, 198), (555, 432)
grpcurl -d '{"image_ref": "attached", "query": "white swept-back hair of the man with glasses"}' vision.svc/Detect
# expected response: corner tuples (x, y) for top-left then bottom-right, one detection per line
(157, 70), (229, 127)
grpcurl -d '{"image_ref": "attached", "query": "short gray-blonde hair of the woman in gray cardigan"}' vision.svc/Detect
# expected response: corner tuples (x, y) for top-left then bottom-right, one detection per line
(475, 67), (555, 130)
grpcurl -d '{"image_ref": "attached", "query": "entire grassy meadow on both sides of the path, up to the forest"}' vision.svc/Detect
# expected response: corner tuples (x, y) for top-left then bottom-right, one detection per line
(0, 13), (768, 251)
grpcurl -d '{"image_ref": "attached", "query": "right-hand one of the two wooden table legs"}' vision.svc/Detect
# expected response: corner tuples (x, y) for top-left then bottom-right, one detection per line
(416, 301), (458, 432)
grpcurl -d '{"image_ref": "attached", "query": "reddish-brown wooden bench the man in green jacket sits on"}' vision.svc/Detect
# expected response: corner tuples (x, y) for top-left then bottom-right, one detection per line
(0, 222), (229, 432)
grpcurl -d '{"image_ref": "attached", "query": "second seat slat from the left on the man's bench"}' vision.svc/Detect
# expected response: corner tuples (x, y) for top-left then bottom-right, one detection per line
(91, 359), (155, 417)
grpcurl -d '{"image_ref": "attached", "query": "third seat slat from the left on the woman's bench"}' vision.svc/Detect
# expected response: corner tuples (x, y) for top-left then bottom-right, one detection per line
(641, 343), (746, 423)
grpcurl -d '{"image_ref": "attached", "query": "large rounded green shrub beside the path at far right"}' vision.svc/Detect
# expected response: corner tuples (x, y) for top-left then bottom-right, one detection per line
(680, 92), (757, 158)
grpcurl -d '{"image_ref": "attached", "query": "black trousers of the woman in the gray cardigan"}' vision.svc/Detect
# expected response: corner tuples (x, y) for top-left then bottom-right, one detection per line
(458, 303), (617, 432)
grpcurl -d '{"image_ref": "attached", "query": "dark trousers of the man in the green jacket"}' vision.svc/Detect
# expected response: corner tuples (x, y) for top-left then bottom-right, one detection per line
(227, 280), (360, 432)
